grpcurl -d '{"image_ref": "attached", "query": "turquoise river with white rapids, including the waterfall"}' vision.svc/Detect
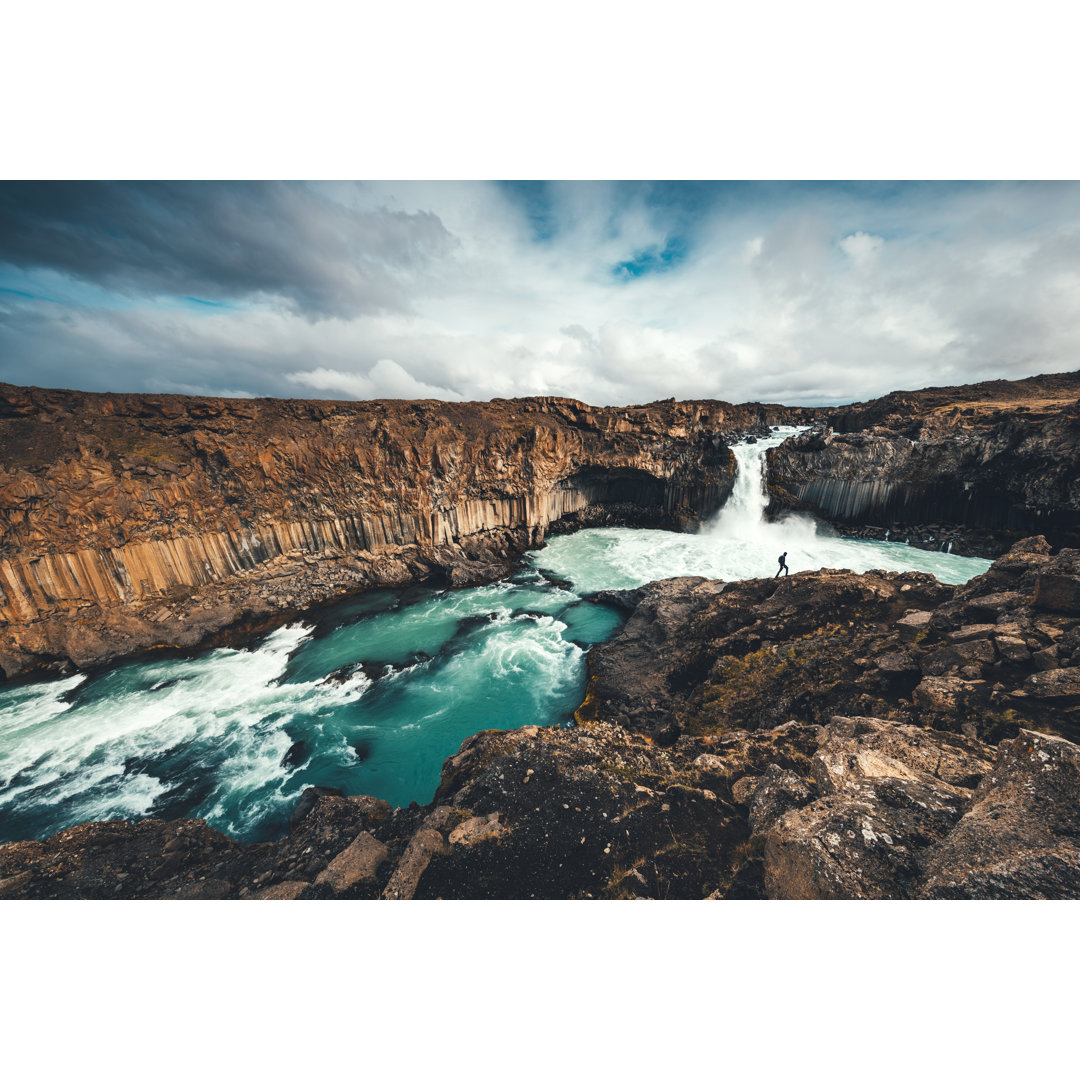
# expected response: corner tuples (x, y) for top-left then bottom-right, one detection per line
(0, 429), (989, 842)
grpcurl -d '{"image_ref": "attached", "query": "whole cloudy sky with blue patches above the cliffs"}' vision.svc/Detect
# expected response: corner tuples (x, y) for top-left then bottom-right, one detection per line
(0, 181), (1080, 405)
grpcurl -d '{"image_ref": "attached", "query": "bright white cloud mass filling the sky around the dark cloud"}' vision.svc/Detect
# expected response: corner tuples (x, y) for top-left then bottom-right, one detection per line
(6, 184), (1080, 404)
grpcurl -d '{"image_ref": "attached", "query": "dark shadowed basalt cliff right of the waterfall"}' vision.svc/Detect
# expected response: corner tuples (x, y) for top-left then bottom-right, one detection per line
(769, 375), (1080, 556)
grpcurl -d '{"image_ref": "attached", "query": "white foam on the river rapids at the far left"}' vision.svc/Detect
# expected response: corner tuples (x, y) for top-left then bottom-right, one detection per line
(0, 625), (380, 822)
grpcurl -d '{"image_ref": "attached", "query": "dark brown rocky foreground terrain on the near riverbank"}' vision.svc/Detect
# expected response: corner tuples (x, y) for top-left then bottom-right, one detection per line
(6, 538), (1080, 900)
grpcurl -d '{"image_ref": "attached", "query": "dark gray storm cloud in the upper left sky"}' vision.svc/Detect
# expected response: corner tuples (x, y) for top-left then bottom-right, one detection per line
(0, 181), (456, 316)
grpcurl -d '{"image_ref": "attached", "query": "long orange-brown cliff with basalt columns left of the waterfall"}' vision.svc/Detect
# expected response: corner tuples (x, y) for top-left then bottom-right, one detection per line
(0, 386), (805, 675)
